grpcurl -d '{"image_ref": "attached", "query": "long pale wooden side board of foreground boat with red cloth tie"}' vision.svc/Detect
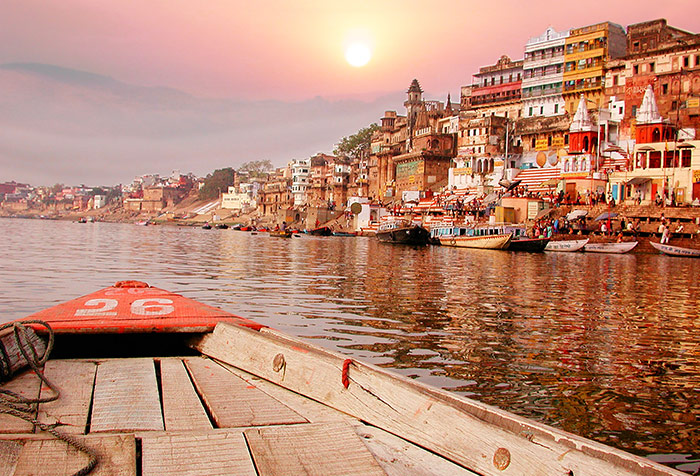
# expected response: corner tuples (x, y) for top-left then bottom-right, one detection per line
(195, 324), (682, 476)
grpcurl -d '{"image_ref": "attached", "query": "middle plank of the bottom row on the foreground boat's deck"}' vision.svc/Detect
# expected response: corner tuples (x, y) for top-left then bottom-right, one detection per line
(141, 431), (256, 476)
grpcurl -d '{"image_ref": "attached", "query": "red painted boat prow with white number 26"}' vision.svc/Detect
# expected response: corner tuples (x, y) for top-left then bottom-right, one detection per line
(26, 281), (265, 334)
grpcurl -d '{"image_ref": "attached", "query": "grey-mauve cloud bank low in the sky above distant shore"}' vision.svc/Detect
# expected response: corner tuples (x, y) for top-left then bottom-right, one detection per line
(0, 64), (404, 185)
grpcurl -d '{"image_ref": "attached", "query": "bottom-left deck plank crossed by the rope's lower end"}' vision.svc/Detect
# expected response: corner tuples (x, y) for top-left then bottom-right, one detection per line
(14, 435), (136, 476)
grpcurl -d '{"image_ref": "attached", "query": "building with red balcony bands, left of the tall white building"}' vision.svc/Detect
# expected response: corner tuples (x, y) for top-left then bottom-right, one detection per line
(460, 55), (523, 119)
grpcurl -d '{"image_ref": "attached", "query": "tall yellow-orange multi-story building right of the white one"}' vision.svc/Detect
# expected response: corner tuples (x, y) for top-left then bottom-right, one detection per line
(562, 22), (627, 115)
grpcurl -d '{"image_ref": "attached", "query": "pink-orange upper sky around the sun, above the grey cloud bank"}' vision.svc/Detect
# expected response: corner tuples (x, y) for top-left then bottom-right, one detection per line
(5, 0), (700, 101)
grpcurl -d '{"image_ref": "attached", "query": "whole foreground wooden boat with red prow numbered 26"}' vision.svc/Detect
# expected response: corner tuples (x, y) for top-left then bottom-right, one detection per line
(0, 282), (683, 476)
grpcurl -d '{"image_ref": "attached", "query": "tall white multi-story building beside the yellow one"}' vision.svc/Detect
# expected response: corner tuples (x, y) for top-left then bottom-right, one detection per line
(522, 27), (569, 117)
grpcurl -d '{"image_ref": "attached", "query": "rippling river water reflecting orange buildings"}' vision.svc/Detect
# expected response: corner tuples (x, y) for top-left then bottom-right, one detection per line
(0, 219), (700, 472)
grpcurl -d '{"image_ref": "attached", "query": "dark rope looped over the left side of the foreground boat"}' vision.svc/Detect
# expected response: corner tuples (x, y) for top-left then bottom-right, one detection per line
(0, 320), (98, 476)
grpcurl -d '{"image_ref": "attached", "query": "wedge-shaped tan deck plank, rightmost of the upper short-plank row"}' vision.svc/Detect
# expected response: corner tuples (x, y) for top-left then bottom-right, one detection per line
(185, 358), (307, 428)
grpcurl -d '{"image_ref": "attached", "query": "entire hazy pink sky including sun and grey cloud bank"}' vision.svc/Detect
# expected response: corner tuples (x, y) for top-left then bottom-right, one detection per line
(0, 0), (700, 183)
